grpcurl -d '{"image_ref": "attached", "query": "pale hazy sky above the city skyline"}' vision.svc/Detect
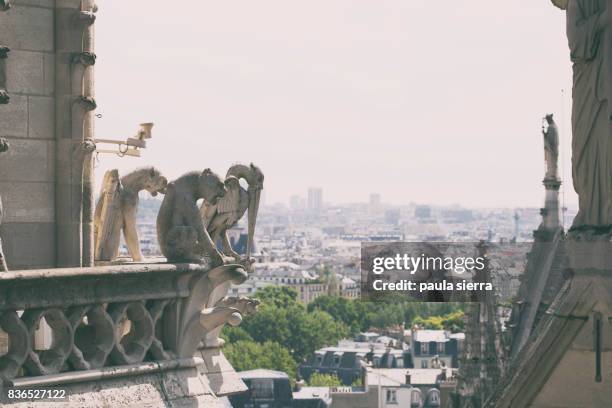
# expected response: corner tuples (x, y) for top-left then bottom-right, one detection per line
(96, 0), (576, 207)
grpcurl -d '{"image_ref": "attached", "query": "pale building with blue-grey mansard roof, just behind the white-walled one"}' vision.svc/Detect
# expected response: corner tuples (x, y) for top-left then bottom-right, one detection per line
(410, 329), (465, 368)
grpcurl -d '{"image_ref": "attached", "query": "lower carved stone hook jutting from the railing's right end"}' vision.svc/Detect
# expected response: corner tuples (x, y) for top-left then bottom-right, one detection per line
(202, 296), (261, 347)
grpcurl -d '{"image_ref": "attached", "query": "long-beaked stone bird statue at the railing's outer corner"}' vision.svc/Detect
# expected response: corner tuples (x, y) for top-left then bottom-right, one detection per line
(200, 163), (264, 264)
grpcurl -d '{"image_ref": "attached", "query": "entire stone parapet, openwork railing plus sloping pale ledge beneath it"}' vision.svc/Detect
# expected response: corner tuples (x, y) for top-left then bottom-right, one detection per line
(0, 264), (247, 406)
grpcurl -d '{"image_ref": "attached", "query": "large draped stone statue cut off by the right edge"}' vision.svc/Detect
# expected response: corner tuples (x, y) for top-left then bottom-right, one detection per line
(553, 0), (612, 233)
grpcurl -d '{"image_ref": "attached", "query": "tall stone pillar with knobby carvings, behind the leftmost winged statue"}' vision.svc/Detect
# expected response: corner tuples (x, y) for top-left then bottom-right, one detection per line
(55, 0), (96, 267)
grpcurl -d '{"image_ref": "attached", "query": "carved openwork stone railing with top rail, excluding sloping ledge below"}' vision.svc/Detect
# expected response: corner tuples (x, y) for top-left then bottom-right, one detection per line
(0, 264), (247, 388)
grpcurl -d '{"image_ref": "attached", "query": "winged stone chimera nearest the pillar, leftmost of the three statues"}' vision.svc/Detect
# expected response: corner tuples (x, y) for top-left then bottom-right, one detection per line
(94, 167), (168, 262)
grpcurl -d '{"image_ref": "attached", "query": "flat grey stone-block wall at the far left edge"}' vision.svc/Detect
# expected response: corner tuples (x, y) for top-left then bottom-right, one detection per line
(0, 0), (56, 270)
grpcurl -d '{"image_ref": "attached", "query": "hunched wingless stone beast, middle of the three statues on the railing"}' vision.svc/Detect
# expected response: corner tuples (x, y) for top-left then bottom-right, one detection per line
(157, 169), (228, 267)
